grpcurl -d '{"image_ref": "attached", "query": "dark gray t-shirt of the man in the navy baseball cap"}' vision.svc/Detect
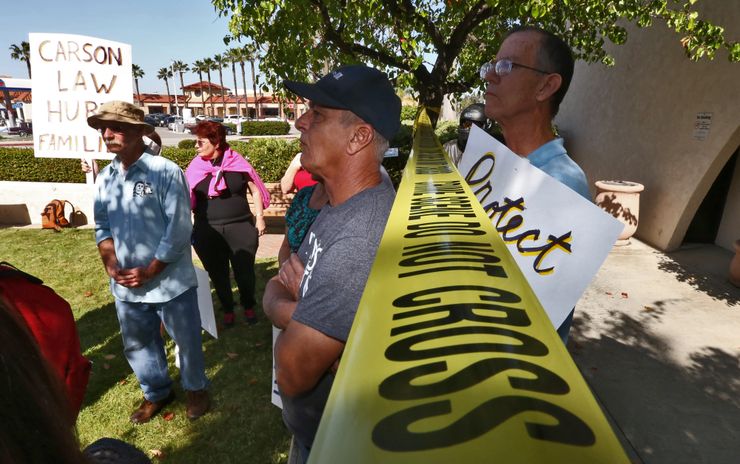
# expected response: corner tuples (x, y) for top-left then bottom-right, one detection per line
(282, 182), (395, 447)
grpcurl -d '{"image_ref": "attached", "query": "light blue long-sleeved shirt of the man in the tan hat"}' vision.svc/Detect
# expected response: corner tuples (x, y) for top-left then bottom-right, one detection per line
(95, 152), (197, 303)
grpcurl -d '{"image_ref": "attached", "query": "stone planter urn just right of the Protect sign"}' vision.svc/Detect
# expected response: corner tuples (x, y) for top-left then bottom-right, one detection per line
(594, 180), (645, 246)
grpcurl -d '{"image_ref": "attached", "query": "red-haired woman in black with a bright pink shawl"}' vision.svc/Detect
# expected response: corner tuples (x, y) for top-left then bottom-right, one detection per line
(185, 121), (270, 327)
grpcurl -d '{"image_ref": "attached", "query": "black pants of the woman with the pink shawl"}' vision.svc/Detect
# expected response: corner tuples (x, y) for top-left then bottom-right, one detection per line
(193, 222), (259, 313)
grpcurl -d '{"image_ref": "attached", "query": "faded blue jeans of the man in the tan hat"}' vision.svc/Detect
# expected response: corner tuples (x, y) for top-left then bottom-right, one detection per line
(116, 287), (208, 401)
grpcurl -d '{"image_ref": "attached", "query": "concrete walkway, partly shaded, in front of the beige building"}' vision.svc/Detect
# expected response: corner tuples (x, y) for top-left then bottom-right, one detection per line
(568, 239), (740, 464)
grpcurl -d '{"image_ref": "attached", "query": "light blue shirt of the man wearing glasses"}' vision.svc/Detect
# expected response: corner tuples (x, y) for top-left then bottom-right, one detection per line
(527, 138), (591, 201)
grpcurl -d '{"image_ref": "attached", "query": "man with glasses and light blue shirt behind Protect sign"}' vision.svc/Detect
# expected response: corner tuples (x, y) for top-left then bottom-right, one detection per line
(480, 26), (590, 343)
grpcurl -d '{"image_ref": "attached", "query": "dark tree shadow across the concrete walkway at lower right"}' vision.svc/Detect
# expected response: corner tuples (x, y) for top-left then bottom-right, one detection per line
(569, 301), (740, 464)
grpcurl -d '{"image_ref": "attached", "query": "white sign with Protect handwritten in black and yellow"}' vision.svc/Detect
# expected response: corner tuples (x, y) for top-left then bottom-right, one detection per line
(458, 126), (624, 328)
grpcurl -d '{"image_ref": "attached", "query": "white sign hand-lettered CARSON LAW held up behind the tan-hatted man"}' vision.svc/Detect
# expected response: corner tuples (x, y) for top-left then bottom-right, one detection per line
(28, 33), (133, 159)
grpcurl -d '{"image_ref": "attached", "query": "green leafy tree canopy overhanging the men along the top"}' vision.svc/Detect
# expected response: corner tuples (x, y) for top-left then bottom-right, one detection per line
(212, 0), (740, 111)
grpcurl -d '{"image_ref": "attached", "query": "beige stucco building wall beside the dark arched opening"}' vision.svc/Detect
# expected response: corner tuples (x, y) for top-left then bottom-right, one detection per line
(555, 0), (740, 250)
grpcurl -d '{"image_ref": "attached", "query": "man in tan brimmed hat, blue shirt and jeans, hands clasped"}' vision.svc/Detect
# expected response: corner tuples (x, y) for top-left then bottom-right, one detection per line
(87, 101), (210, 424)
